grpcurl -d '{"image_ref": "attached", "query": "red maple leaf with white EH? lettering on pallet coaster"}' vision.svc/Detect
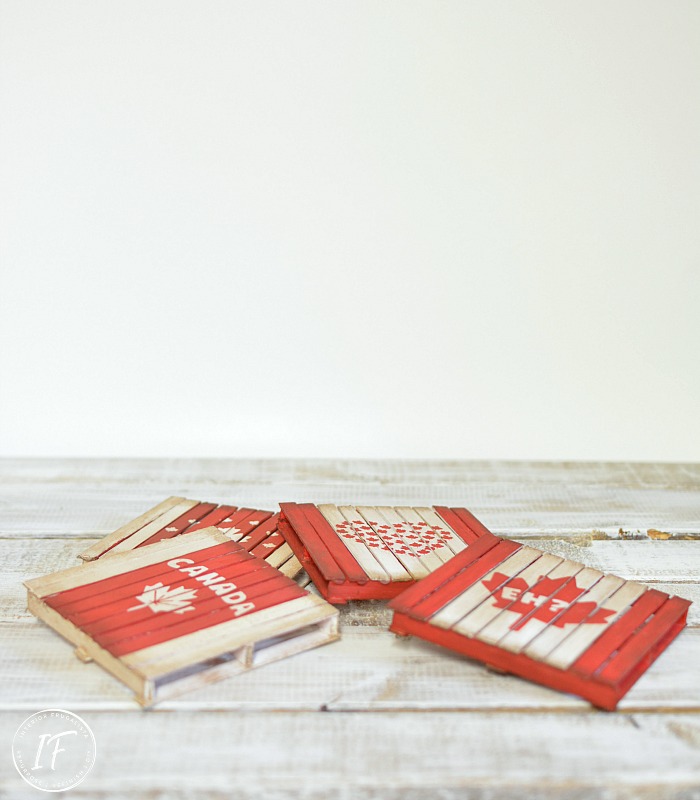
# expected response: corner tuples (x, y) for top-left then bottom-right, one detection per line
(482, 572), (615, 630)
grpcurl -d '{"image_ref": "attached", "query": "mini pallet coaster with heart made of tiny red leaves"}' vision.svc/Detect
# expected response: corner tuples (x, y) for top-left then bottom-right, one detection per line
(279, 503), (488, 603)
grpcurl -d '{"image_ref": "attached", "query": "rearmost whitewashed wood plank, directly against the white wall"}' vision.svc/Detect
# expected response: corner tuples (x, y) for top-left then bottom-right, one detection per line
(0, 459), (700, 538)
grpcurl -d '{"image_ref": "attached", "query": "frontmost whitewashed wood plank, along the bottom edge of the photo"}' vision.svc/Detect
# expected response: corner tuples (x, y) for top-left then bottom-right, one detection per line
(0, 712), (700, 800)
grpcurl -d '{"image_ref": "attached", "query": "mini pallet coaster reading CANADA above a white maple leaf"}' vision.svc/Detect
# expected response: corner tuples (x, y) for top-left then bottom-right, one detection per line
(25, 528), (338, 706)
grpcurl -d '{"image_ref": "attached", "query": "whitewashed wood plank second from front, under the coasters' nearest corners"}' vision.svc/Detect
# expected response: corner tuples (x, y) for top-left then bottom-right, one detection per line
(0, 618), (700, 712)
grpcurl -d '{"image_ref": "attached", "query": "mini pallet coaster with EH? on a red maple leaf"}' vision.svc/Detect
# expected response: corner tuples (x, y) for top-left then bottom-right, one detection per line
(390, 535), (690, 710)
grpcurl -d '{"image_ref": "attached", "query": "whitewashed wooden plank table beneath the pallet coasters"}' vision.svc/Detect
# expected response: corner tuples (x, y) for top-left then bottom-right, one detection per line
(0, 459), (700, 800)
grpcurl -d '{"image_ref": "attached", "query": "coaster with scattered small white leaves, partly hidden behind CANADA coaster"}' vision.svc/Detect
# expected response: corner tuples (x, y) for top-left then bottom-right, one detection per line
(80, 497), (308, 583)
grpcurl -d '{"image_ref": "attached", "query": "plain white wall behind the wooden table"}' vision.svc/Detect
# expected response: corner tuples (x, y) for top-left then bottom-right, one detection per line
(0, 0), (700, 460)
